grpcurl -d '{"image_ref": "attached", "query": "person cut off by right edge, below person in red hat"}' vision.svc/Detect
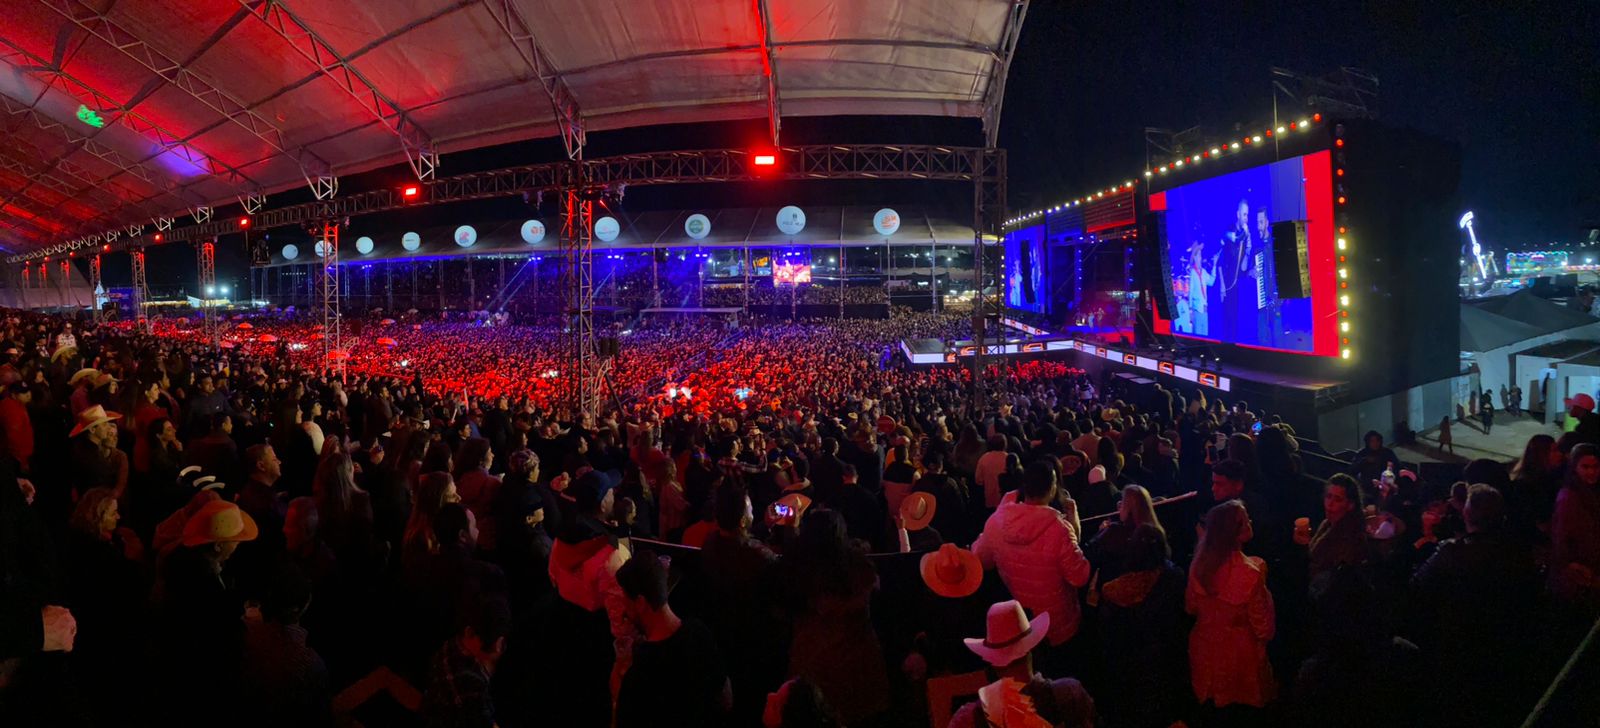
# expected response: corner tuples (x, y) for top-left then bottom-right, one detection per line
(1549, 443), (1600, 614)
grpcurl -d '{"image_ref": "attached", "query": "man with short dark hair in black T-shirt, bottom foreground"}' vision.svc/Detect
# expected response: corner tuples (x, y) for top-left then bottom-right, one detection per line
(616, 552), (733, 728)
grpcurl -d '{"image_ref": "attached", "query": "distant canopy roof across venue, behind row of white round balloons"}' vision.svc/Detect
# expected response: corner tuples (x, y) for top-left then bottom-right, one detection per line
(270, 205), (973, 266)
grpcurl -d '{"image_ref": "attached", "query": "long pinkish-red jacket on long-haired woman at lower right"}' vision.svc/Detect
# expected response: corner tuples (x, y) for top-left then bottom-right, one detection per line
(1184, 554), (1277, 707)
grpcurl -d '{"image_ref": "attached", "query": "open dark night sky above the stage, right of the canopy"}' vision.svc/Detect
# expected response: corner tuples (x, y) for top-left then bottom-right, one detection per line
(1000, 0), (1600, 248)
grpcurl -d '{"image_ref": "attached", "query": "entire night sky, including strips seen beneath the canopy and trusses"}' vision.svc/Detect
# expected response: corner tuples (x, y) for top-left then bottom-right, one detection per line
(134, 0), (1600, 286)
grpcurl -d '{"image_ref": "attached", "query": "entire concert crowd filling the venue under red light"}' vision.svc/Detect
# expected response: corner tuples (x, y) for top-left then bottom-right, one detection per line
(0, 312), (1600, 728)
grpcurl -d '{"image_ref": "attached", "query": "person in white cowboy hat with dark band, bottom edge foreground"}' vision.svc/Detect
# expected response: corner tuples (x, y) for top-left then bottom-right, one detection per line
(950, 600), (1094, 728)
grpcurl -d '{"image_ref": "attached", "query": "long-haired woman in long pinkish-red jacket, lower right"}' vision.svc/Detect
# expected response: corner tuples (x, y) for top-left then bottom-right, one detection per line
(1184, 501), (1277, 707)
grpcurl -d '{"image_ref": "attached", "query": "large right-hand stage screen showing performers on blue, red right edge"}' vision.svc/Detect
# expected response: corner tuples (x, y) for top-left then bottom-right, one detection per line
(1150, 152), (1339, 357)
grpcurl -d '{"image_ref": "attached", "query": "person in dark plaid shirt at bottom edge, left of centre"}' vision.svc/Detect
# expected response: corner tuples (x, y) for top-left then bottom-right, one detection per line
(418, 595), (512, 728)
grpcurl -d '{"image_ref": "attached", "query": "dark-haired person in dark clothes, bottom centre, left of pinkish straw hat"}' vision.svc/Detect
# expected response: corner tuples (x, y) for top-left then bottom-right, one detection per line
(782, 509), (890, 725)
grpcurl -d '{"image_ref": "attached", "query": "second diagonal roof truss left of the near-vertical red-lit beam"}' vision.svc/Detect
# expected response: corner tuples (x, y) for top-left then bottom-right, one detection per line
(238, 0), (438, 181)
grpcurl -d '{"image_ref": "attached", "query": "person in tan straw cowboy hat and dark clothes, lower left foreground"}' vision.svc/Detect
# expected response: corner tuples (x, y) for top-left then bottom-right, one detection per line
(154, 501), (259, 725)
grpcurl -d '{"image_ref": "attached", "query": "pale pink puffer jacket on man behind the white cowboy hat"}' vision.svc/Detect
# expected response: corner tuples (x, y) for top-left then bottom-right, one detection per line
(973, 502), (1090, 645)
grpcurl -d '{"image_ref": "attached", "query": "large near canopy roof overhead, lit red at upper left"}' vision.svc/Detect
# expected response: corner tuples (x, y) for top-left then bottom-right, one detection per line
(0, 0), (1027, 253)
